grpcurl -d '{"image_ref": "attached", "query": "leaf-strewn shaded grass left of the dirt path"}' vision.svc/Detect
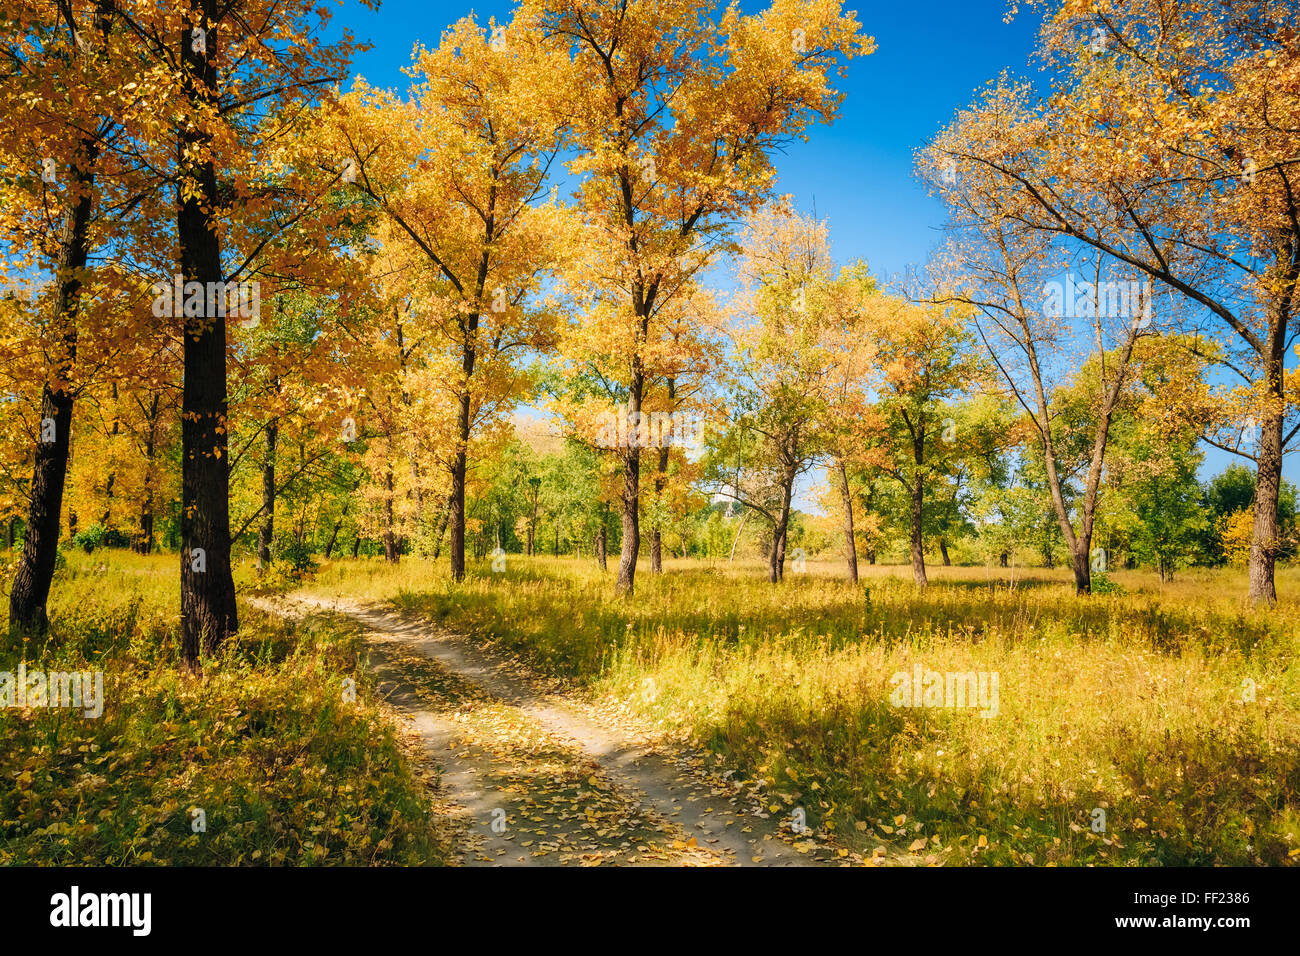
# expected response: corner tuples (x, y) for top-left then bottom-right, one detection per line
(0, 551), (447, 865)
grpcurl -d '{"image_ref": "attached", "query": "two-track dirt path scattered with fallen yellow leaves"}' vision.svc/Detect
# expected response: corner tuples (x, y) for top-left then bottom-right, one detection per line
(257, 598), (862, 866)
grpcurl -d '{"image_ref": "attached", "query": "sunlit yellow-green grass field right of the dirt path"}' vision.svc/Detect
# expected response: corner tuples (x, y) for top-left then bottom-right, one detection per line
(306, 555), (1300, 865)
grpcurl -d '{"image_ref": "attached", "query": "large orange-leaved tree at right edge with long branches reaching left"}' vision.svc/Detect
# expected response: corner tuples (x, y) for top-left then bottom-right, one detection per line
(935, 0), (1300, 605)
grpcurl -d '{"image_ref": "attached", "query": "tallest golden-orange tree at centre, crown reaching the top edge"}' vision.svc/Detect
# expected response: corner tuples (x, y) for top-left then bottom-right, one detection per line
(533, 0), (872, 594)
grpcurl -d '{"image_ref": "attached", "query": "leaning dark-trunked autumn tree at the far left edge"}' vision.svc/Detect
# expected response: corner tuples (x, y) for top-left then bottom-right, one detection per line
(0, 0), (138, 632)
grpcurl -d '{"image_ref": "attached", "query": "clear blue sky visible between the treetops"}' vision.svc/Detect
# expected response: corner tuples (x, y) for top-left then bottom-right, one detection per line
(335, 0), (1300, 510)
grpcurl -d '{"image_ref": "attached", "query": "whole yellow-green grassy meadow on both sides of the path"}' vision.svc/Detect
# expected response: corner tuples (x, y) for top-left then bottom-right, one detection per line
(0, 549), (1300, 865)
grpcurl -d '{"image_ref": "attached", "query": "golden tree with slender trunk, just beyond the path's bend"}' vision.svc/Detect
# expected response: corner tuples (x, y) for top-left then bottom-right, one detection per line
(321, 18), (566, 580)
